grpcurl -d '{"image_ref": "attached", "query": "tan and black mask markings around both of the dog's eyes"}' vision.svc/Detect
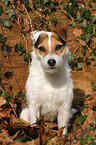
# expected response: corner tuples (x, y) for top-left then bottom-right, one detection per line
(35, 32), (66, 57)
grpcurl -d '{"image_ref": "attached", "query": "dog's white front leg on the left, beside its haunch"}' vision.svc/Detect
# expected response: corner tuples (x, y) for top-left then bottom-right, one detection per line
(29, 104), (39, 126)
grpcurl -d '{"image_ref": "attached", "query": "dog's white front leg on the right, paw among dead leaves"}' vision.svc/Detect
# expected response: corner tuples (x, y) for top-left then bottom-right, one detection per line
(58, 107), (70, 135)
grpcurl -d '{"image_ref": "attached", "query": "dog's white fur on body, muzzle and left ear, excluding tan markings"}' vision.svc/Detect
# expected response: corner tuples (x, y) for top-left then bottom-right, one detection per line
(20, 31), (73, 134)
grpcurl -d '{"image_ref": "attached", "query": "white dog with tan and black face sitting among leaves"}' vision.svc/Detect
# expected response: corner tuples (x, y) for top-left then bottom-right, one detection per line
(20, 30), (73, 135)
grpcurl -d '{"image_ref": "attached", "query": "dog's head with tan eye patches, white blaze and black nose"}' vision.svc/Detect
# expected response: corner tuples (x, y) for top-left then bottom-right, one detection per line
(31, 30), (68, 73)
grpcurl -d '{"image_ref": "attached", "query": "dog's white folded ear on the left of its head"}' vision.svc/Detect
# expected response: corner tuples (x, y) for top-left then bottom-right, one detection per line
(30, 30), (45, 44)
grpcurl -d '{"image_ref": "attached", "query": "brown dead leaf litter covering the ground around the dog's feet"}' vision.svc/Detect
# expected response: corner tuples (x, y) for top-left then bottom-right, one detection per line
(0, 1), (96, 145)
